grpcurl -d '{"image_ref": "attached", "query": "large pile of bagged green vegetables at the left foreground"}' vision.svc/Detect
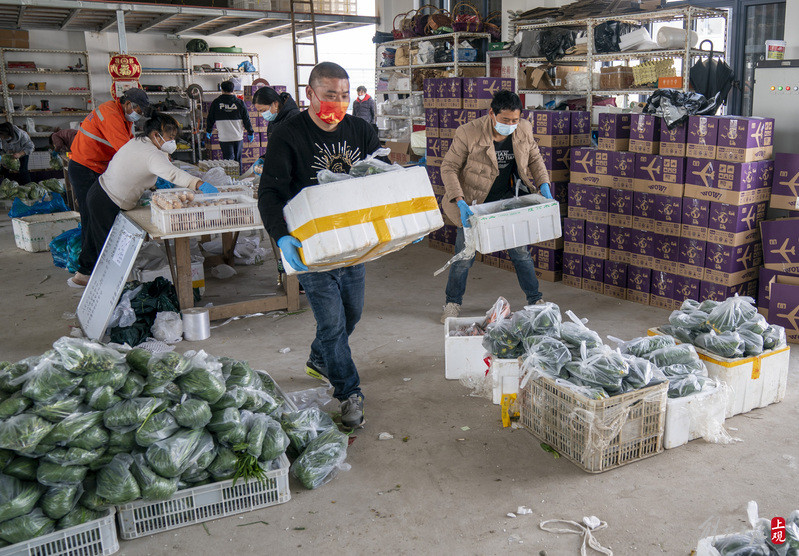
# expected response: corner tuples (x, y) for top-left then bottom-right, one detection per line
(0, 337), (304, 546)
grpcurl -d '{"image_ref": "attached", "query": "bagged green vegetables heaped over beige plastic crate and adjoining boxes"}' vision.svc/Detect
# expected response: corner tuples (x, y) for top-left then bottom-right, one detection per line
(483, 298), (710, 400)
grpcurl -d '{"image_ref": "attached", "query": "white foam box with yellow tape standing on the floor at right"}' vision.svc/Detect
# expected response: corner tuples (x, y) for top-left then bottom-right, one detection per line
(649, 328), (791, 419)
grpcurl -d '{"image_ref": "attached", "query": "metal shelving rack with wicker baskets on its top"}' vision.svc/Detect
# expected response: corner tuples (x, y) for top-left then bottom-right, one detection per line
(375, 33), (491, 140)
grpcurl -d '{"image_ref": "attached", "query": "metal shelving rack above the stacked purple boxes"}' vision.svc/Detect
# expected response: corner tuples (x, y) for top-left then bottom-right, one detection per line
(516, 6), (729, 111)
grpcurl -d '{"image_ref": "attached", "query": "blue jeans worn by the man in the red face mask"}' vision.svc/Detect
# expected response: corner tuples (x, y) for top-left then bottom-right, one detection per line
(297, 264), (366, 401)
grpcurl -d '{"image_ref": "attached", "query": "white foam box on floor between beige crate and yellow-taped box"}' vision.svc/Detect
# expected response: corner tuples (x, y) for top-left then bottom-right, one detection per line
(663, 380), (727, 450)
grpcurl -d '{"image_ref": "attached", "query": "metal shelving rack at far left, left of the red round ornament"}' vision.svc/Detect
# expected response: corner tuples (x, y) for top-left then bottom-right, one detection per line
(0, 48), (94, 132)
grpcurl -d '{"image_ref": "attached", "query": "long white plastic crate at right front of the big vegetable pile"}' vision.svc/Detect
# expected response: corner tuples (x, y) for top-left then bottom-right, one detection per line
(117, 454), (291, 540)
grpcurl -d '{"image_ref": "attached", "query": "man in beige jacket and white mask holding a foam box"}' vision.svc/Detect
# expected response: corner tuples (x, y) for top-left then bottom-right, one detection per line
(441, 91), (552, 323)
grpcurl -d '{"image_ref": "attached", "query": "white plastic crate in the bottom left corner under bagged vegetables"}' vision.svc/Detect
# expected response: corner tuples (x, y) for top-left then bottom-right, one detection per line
(0, 508), (119, 556)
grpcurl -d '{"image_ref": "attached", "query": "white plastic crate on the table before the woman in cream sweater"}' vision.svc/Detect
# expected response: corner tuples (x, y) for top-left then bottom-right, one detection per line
(150, 193), (261, 233)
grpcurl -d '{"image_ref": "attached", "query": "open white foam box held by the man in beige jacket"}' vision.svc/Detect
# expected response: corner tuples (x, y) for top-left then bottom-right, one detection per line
(472, 195), (563, 253)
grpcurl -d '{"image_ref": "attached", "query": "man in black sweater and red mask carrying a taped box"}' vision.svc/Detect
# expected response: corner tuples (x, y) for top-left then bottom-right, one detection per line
(258, 62), (380, 428)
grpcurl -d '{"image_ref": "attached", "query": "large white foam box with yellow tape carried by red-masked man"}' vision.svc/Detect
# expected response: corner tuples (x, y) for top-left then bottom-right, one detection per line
(283, 166), (444, 274)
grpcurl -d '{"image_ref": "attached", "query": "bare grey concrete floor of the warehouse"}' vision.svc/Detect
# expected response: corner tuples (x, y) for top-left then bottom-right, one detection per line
(0, 212), (799, 556)
